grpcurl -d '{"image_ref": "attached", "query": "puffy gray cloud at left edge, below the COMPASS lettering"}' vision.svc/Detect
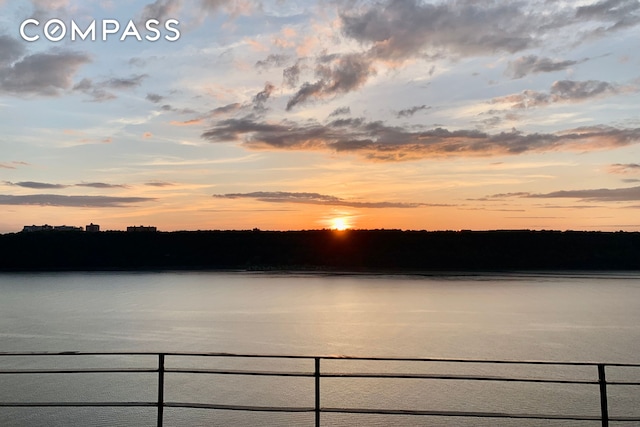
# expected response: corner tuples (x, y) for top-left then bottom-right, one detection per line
(0, 51), (90, 96)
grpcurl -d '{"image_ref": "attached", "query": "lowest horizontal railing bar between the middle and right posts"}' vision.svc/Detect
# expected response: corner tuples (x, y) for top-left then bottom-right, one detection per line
(321, 408), (600, 421)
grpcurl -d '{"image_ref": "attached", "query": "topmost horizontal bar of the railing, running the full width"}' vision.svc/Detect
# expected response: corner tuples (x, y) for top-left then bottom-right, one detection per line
(0, 351), (640, 368)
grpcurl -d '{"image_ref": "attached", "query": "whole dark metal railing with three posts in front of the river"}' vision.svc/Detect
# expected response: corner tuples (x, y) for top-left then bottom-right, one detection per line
(0, 352), (640, 427)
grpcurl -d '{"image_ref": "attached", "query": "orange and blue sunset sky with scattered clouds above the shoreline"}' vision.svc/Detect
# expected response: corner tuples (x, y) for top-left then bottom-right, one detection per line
(0, 0), (640, 233)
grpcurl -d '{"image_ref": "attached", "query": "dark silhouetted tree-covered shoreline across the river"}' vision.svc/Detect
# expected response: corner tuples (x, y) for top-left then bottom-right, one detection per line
(0, 230), (640, 274)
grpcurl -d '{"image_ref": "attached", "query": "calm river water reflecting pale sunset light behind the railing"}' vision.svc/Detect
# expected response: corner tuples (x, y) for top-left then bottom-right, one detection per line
(0, 272), (640, 426)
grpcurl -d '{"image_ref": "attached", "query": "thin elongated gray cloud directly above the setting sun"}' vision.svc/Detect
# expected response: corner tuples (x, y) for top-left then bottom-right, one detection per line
(213, 191), (441, 209)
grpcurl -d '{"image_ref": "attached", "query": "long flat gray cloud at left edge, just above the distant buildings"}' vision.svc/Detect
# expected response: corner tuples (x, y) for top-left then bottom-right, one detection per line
(0, 194), (156, 208)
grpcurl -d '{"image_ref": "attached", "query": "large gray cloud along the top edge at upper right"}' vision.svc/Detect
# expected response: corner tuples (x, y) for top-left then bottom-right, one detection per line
(340, 0), (640, 62)
